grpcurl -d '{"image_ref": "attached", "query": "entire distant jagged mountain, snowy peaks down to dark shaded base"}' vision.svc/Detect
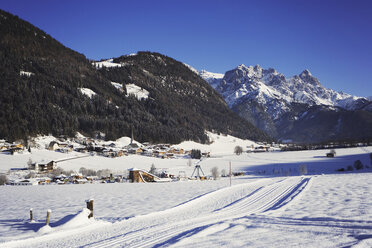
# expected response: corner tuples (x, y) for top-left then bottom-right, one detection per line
(199, 65), (372, 143)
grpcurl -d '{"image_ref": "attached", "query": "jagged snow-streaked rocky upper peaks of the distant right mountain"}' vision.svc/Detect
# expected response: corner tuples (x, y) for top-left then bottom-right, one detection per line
(214, 64), (368, 109)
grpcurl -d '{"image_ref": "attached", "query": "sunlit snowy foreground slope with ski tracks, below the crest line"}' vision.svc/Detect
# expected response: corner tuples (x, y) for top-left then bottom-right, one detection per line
(0, 173), (372, 247)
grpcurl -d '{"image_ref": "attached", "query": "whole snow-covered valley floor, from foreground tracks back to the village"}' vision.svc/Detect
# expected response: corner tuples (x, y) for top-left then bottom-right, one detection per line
(0, 140), (372, 247)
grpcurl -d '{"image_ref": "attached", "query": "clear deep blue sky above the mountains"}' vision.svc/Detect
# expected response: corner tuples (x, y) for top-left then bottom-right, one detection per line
(0, 0), (372, 96)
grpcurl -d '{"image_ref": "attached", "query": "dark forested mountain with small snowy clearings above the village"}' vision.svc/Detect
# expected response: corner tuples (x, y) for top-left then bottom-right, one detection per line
(0, 10), (270, 143)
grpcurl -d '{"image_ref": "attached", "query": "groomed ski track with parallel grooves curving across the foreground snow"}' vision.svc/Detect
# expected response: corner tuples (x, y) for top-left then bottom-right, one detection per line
(5, 177), (311, 247)
